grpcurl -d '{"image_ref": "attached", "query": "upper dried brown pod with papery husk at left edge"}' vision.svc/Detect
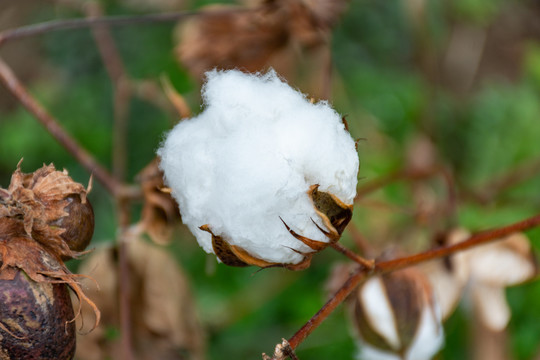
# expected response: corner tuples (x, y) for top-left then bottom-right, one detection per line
(0, 164), (94, 260)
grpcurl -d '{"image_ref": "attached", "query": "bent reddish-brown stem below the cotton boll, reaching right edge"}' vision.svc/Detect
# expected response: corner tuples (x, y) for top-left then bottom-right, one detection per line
(276, 214), (540, 360)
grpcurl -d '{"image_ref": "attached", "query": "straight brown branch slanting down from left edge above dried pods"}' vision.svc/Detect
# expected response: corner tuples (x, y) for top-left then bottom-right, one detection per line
(0, 58), (118, 194)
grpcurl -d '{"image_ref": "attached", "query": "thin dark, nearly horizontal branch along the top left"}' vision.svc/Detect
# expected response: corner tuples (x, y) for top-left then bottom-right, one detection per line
(0, 8), (255, 46)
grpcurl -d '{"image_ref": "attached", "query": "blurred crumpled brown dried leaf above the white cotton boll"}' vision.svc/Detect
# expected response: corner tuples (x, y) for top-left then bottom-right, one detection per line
(175, 0), (349, 78)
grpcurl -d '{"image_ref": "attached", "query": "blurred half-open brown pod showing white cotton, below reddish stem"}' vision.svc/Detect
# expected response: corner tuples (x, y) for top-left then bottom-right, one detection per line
(352, 268), (443, 360)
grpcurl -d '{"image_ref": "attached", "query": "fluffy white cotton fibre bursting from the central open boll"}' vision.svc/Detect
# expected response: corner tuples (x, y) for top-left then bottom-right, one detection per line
(158, 70), (358, 264)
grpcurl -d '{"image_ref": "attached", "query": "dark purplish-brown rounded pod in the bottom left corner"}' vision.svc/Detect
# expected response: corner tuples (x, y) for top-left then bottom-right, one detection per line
(0, 271), (75, 360)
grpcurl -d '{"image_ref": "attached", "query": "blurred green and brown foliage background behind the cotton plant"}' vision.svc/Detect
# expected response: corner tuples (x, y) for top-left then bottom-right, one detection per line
(0, 0), (540, 360)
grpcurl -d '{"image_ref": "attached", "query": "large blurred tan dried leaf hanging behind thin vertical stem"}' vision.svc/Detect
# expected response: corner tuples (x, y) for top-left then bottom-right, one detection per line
(77, 238), (204, 360)
